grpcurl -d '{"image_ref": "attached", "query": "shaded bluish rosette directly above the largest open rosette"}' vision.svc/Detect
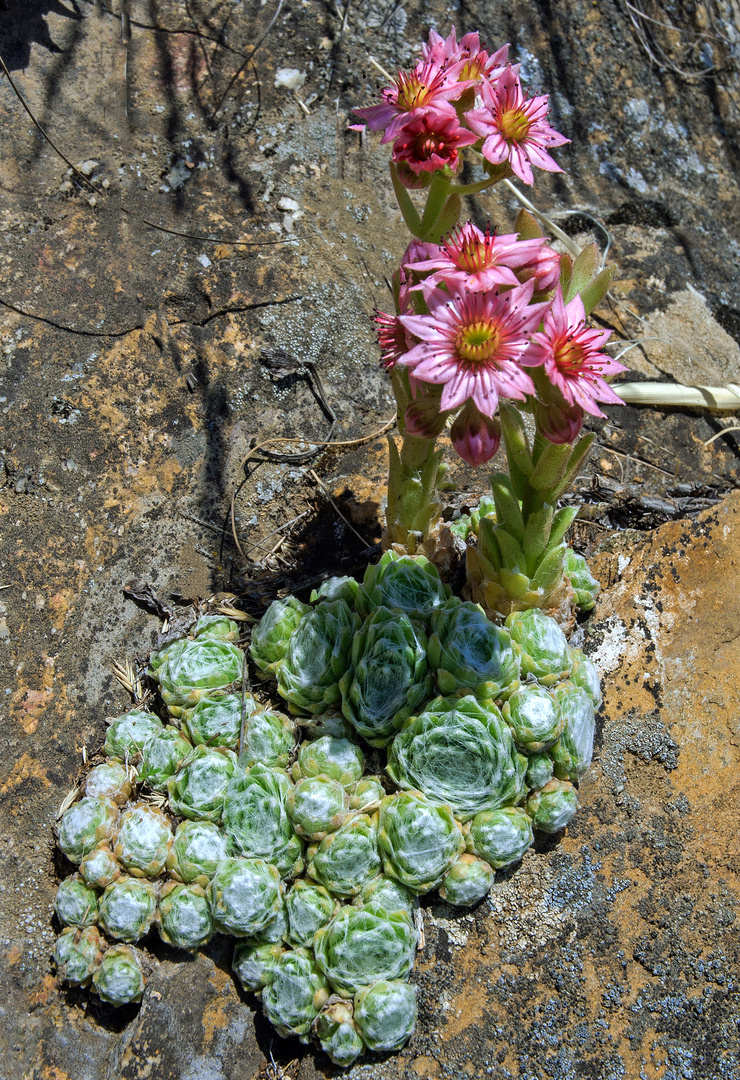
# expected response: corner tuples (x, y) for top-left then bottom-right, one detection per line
(427, 596), (521, 701)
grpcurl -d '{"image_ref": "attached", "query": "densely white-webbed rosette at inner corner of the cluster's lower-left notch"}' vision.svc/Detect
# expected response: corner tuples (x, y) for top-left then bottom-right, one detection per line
(207, 858), (282, 937)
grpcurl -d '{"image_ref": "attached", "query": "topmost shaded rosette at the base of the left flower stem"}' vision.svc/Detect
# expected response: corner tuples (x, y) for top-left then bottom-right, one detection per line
(354, 551), (450, 619)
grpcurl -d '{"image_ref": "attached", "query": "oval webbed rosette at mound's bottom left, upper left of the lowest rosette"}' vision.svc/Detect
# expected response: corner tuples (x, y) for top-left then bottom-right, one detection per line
(263, 949), (331, 1042)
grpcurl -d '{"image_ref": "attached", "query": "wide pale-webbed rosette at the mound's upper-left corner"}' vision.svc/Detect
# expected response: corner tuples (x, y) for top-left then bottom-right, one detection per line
(160, 637), (244, 717)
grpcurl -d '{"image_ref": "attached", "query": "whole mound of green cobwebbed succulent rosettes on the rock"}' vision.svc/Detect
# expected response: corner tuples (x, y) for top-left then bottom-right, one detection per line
(55, 552), (600, 1066)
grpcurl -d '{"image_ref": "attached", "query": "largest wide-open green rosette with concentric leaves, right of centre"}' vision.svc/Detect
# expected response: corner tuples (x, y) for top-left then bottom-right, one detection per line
(387, 696), (526, 822)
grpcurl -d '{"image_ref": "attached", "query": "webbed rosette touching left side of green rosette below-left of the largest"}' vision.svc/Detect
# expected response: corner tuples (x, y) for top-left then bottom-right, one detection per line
(306, 814), (380, 896)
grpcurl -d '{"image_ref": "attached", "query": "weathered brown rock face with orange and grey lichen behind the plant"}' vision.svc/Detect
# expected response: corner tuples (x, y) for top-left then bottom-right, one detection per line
(0, 0), (740, 1080)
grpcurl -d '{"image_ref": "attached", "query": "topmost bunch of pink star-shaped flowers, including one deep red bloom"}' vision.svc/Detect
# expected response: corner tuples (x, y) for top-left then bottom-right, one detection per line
(354, 28), (569, 187)
